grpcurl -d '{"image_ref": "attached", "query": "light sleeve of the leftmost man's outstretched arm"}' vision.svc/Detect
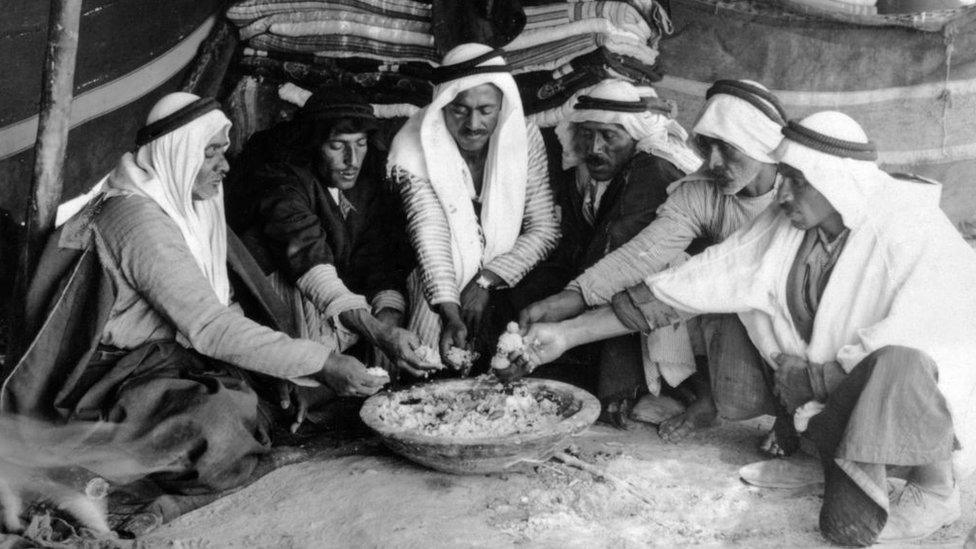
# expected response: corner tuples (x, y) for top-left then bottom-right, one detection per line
(94, 196), (333, 378)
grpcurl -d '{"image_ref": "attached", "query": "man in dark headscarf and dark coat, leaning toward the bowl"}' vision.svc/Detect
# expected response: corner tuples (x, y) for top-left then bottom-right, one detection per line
(234, 88), (433, 382)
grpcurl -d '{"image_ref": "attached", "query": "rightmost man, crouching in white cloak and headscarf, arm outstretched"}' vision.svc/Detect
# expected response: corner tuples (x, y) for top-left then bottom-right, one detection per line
(517, 112), (976, 545)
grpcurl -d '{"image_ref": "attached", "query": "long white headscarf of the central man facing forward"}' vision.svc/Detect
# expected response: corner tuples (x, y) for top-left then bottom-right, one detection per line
(387, 44), (528, 287)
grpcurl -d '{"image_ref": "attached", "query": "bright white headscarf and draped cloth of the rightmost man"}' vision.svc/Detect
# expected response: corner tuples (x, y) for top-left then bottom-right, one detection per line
(645, 112), (976, 475)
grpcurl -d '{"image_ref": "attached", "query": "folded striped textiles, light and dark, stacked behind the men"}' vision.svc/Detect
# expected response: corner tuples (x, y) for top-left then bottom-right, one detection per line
(227, 0), (671, 126)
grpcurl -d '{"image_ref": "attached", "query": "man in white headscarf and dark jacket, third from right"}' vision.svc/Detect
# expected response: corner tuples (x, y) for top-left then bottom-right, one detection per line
(504, 79), (701, 414)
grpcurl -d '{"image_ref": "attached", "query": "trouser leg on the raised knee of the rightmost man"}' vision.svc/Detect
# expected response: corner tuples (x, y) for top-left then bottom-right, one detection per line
(805, 346), (955, 546)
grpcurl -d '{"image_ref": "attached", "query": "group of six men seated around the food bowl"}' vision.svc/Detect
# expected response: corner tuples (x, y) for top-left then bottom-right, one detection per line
(0, 44), (976, 545)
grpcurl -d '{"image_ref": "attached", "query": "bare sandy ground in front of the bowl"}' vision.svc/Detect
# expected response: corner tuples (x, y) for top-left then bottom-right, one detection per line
(137, 421), (976, 548)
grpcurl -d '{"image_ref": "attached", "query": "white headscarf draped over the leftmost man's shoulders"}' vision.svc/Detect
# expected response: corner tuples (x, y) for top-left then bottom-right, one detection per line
(104, 93), (231, 305)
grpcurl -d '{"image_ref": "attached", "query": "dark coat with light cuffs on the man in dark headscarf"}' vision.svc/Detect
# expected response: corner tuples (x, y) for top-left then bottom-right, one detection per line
(244, 161), (411, 318)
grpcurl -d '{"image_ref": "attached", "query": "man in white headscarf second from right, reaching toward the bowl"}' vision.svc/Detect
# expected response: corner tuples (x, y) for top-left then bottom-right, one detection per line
(522, 80), (791, 440)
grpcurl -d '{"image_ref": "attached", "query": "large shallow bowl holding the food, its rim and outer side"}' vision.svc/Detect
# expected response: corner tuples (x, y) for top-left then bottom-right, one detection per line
(359, 379), (600, 475)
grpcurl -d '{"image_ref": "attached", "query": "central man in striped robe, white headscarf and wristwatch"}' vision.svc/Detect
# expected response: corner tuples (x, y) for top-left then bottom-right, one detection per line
(387, 44), (559, 366)
